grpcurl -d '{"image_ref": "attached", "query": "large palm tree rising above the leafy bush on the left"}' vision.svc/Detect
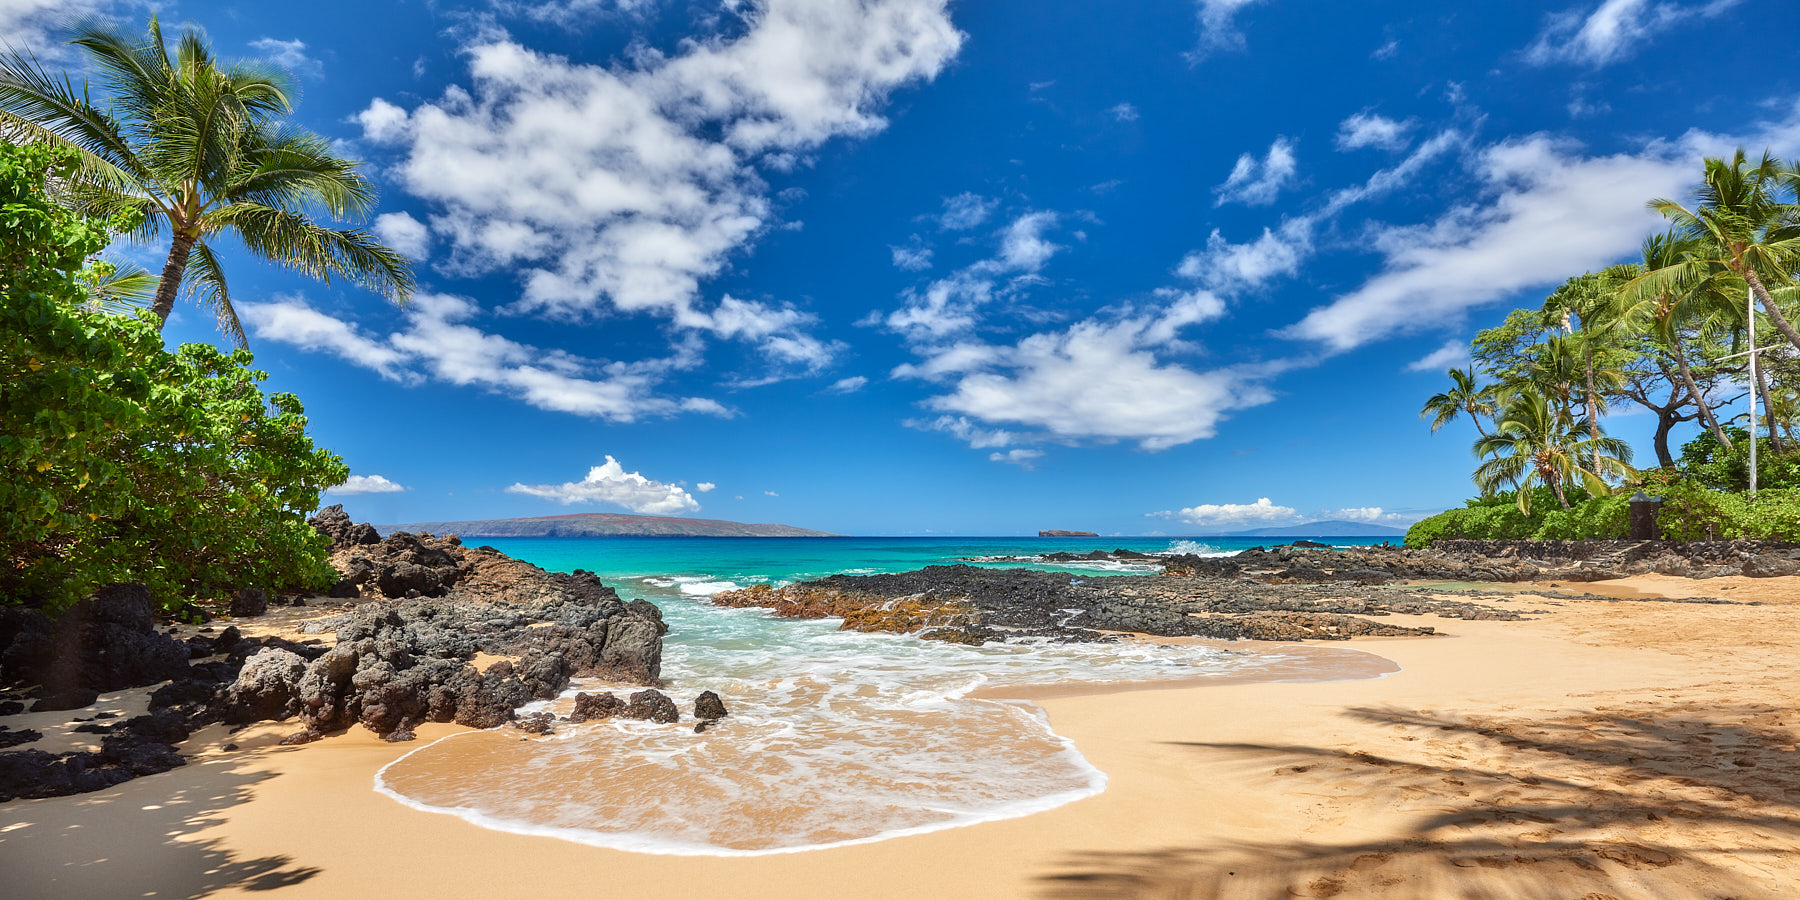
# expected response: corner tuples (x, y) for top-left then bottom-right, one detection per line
(0, 18), (412, 346)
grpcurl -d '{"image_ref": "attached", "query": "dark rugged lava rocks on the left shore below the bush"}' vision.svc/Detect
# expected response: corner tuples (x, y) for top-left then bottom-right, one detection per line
(0, 506), (691, 803)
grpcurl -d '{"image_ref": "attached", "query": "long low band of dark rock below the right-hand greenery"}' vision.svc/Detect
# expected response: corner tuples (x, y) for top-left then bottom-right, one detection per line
(1165, 540), (1800, 583)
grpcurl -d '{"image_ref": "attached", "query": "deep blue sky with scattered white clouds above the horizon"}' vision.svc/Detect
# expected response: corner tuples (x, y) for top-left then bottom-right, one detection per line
(0, 0), (1800, 535)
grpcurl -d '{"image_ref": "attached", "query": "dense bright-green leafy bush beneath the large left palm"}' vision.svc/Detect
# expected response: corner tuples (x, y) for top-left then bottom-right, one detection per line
(0, 144), (349, 605)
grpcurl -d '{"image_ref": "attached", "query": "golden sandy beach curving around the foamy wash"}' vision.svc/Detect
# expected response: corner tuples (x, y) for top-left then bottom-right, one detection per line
(0, 576), (1800, 900)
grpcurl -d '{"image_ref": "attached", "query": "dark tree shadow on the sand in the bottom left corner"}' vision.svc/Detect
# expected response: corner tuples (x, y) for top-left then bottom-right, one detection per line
(0, 751), (322, 900)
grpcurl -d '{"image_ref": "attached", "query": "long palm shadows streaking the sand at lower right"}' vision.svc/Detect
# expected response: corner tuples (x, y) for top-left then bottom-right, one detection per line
(1039, 700), (1800, 900)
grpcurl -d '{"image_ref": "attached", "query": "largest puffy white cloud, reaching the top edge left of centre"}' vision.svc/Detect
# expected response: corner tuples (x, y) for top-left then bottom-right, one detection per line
(356, 0), (963, 354)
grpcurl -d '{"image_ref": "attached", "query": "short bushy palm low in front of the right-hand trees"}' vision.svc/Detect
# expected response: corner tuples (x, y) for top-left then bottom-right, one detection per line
(1474, 387), (1631, 515)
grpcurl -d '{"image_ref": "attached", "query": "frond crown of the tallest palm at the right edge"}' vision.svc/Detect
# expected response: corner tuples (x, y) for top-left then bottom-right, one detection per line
(1633, 149), (1800, 347)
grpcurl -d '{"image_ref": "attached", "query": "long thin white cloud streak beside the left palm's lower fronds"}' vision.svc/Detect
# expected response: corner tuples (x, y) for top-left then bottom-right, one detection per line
(238, 293), (729, 421)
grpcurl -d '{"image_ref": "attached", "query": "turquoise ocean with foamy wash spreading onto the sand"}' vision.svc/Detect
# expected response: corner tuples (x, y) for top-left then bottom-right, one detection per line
(376, 536), (1391, 855)
